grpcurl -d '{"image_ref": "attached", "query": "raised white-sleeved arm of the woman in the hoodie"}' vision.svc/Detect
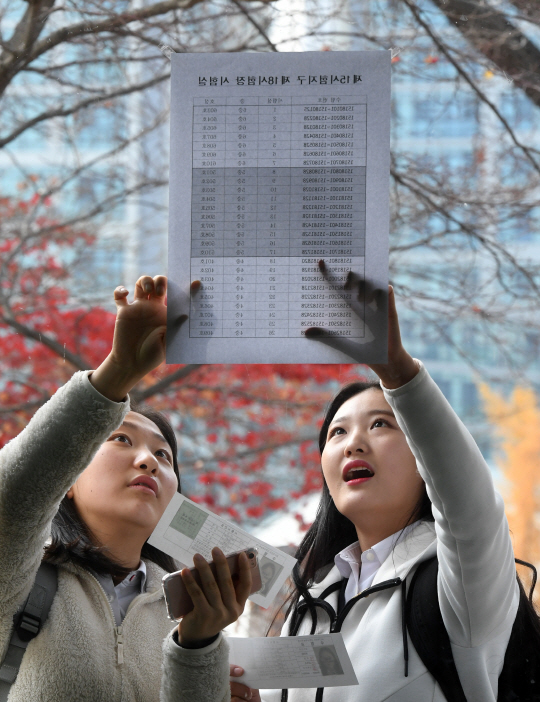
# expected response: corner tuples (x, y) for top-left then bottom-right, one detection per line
(362, 289), (517, 648)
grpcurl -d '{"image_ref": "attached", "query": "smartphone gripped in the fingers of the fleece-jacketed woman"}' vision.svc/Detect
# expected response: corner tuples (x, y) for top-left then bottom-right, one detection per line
(162, 547), (262, 622)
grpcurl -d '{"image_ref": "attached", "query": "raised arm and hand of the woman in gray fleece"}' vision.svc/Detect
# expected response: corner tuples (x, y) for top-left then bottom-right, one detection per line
(0, 276), (181, 619)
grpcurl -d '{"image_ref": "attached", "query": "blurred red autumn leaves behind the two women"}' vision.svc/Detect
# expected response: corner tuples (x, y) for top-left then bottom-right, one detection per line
(0, 196), (368, 522)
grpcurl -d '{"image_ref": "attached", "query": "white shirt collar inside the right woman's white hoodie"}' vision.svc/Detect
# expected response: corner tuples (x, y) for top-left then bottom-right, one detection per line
(334, 521), (420, 602)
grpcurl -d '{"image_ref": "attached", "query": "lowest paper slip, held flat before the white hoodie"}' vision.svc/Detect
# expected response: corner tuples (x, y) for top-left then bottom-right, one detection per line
(227, 634), (358, 689)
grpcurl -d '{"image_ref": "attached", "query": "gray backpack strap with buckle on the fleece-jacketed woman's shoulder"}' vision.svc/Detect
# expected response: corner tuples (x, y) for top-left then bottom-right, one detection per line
(0, 562), (58, 702)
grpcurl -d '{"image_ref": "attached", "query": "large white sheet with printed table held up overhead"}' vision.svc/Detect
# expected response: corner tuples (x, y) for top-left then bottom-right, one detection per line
(167, 51), (390, 362)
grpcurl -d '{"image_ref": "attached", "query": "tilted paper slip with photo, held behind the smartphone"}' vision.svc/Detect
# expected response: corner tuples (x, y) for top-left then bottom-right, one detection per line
(148, 493), (296, 608)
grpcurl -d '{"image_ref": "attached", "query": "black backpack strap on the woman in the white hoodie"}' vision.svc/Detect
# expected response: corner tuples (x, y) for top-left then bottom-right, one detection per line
(405, 556), (467, 702)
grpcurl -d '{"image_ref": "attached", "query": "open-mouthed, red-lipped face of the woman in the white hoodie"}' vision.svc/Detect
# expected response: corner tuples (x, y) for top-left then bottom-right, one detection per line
(321, 388), (424, 548)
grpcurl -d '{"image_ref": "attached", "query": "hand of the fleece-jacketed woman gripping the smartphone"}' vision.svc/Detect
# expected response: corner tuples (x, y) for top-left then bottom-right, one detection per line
(178, 548), (251, 648)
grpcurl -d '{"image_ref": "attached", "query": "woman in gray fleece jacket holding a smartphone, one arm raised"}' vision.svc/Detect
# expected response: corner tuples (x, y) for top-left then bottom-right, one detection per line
(0, 276), (251, 702)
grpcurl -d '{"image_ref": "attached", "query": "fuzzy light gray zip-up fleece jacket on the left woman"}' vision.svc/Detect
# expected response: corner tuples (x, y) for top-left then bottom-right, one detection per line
(0, 372), (230, 702)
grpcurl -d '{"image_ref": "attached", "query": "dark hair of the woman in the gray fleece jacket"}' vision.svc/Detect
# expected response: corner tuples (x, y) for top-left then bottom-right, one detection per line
(43, 404), (181, 579)
